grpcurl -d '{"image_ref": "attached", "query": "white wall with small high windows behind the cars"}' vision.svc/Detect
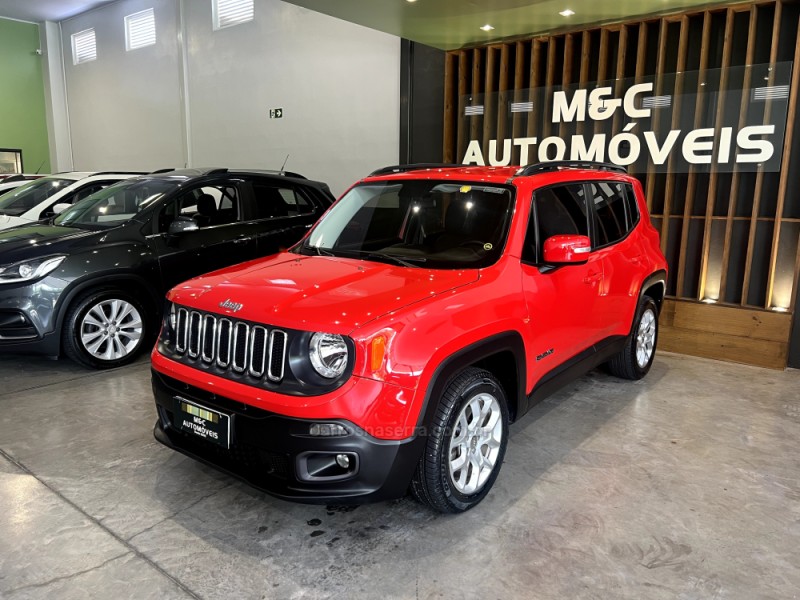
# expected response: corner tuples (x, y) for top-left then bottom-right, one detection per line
(57, 0), (400, 194)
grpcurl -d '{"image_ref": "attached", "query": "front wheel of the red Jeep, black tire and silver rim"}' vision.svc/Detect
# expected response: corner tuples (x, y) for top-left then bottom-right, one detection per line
(411, 367), (509, 513)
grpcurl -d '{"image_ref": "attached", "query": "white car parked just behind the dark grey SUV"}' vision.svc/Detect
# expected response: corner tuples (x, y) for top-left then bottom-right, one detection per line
(0, 171), (144, 229)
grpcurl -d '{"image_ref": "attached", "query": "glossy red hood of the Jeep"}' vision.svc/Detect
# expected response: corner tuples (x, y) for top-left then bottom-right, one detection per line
(169, 254), (479, 334)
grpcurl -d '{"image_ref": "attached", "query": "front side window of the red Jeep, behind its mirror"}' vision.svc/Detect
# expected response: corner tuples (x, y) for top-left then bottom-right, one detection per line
(522, 184), (589, 263)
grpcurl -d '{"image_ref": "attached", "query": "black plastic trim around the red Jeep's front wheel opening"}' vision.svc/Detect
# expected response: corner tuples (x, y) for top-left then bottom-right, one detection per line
(417, 331), (526, 432)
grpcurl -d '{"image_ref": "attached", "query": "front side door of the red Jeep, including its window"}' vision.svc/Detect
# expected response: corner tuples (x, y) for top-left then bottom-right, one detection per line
(522, 183), (603, 382)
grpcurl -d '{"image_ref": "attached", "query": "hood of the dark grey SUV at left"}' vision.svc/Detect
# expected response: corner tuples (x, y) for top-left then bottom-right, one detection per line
(0, 224), (102, 264)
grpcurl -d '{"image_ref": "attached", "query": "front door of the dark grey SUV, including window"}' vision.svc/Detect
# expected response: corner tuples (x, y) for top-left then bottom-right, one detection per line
(148, 182), (258, 289)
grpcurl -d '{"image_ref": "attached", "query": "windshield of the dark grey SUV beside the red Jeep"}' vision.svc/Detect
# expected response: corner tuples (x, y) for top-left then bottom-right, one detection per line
(54, 178), (175, 229)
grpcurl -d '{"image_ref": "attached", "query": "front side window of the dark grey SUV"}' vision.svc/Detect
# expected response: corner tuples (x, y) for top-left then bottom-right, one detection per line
(158, 185), (242, 233)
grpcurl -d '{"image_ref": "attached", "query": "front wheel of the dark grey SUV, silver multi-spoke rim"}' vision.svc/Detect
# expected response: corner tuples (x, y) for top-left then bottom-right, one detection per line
(61, 289), (152, 369)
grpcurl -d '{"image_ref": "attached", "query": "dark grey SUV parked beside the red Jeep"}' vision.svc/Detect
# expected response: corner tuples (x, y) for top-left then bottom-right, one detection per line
(0, 169), (334, 368)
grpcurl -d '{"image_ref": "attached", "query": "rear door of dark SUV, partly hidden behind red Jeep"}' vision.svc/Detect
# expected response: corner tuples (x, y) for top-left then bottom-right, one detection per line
(248, 177), (323, 256)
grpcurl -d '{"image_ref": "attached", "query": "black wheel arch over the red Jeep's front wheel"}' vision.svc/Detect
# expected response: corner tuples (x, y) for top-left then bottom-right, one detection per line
(417, 331), (526, 431)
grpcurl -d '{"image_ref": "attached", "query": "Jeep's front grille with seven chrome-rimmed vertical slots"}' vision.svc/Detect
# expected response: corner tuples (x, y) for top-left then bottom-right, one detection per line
(175, 308), (288, 382)
